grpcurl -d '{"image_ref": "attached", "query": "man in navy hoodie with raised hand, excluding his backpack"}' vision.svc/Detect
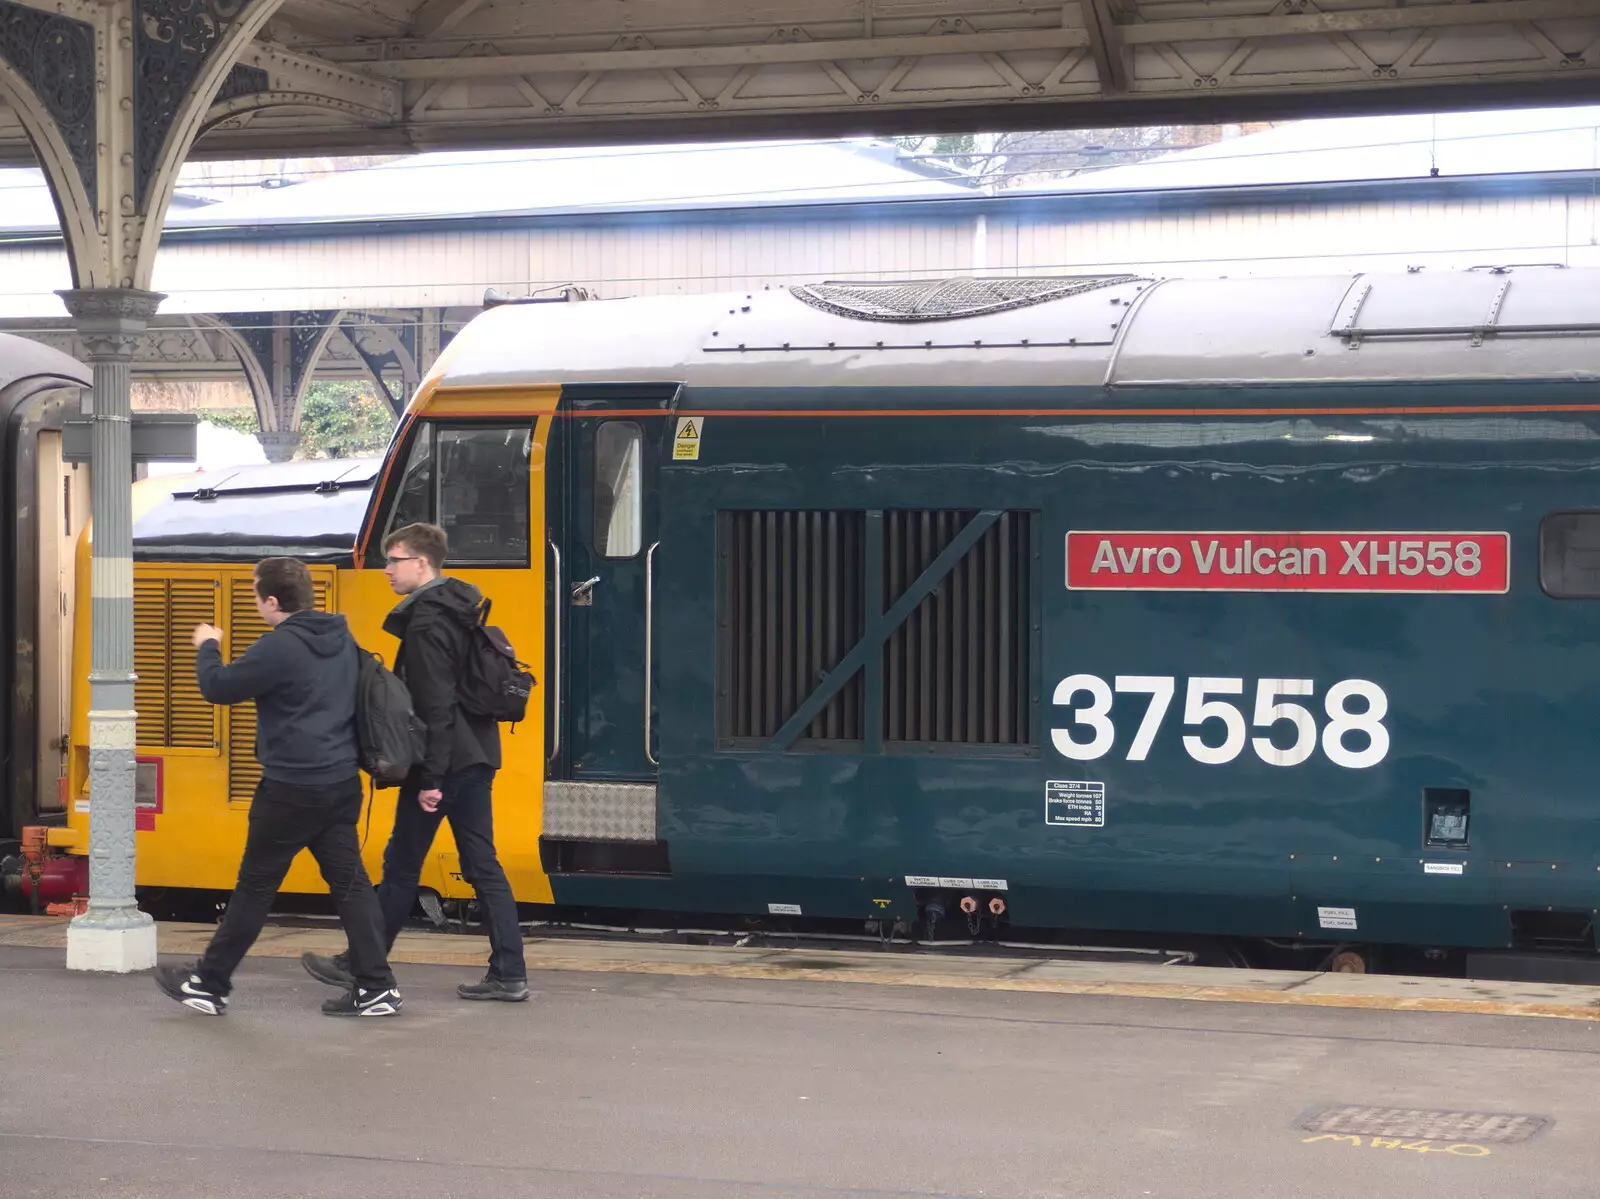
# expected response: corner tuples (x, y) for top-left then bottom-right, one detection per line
(155, 557), (400, 1017)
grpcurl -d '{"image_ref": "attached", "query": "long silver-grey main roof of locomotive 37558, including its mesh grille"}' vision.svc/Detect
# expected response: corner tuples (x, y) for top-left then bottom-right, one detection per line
(434, 266), (1600, 387)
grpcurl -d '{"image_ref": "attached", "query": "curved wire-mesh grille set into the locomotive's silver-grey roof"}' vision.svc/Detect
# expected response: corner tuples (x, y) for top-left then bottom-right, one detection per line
(789, 275), (1139, 322)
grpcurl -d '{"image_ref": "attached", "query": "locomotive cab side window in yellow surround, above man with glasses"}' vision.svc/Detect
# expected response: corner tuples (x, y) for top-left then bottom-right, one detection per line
(380, 424), (533, 567)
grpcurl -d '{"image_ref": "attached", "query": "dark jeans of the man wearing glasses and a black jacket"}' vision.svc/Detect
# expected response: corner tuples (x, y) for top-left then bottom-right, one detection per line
(374, 767), (528, 981)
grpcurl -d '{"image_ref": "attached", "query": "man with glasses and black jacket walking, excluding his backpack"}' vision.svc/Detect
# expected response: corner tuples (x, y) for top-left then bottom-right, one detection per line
(301, 525), (528, 1004)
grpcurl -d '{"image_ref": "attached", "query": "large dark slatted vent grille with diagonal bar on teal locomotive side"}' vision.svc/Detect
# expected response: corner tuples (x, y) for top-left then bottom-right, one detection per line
(717, 509), (1035, 754)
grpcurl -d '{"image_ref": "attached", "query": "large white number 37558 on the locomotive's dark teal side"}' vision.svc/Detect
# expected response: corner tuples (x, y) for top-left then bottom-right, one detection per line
(1050, 674), (1389, 770)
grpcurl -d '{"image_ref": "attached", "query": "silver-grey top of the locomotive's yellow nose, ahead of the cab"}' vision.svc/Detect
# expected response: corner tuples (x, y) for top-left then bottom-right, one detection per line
(133, 458), (382, 562)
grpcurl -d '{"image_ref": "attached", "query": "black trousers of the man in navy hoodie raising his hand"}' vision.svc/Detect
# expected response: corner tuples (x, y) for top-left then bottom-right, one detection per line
(195, 775), (395, 996)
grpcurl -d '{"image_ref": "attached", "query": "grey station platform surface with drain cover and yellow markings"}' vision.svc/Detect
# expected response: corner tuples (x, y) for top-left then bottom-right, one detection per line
(0, 917), (1600, 1199)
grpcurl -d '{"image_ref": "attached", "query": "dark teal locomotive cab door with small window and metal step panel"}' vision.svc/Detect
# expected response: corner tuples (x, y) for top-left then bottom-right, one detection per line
(544, 387), (677, 858)
